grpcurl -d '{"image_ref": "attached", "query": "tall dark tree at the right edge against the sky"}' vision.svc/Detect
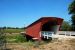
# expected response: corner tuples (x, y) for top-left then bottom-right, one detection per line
(68, 0), (75, 31)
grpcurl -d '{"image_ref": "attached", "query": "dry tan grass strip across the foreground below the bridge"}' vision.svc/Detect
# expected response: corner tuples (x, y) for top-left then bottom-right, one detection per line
(7, 39), (75, 50)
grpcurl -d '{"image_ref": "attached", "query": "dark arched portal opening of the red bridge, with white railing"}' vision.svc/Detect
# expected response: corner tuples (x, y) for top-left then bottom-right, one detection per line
(41, 21), (57, 40)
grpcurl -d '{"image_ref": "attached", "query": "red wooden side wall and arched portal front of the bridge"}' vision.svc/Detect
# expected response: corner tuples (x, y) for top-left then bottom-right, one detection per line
(26, 17), (63, 39)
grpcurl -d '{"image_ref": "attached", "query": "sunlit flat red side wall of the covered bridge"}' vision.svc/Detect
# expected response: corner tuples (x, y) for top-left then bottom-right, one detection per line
(26, 22), (41, 38)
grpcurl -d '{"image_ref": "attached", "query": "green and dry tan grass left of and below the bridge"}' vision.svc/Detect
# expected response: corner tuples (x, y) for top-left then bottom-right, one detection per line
(0, 29), (75, 50)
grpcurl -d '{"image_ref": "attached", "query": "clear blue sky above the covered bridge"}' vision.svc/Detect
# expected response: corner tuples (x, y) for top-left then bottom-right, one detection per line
(0, 0), (72, 27)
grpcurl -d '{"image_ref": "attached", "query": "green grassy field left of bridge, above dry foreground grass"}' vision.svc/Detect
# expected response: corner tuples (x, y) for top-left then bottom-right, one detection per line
(0, 27), (26, 42)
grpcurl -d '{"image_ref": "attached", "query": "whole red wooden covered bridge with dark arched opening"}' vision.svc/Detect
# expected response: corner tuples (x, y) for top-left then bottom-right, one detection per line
(25, 17), (63, 40)
